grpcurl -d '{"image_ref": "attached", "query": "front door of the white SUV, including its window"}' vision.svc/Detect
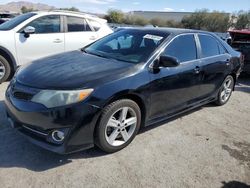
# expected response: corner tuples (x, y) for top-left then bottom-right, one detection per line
(15, 15), (64, 64)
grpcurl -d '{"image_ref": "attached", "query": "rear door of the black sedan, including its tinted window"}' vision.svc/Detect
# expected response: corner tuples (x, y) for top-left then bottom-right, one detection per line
(198, 34), (231, 99)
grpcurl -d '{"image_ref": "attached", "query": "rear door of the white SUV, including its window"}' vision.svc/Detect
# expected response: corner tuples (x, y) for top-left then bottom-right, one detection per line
(65, 16), (98, 51)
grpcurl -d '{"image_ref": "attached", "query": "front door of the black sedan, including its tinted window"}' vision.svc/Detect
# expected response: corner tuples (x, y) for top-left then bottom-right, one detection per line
(150, 34), (199, 119)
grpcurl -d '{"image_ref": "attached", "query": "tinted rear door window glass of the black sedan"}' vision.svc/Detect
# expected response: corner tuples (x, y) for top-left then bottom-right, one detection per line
(199, 35), (220, 58)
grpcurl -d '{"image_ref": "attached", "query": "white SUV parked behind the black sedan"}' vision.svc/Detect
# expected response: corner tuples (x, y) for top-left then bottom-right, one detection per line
(0, 11), (112, 83)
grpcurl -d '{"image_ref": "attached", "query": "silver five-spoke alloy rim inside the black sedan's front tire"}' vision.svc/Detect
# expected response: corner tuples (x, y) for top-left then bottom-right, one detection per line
(105, 107), (137, 146)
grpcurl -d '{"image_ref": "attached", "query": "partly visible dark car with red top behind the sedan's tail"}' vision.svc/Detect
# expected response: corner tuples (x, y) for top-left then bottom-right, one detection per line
(229, 30), (250, 74)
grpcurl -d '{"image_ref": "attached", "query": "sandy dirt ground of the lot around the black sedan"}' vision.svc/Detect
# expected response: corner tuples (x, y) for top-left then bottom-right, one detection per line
(0, 78), (250, 188)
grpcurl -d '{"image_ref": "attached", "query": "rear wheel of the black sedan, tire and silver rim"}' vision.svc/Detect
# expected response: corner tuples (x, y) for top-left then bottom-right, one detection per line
(215, 75), (234, 106)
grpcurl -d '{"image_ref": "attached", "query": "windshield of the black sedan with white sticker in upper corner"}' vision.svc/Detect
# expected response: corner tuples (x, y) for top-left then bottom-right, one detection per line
(83, 29), (169, 63)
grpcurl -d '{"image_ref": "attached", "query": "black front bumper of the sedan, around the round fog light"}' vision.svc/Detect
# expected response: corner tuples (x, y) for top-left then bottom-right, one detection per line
(5, 83), (101, 154)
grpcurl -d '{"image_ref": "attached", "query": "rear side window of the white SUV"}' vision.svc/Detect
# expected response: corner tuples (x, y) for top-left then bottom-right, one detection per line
(67, 16), (92, 32)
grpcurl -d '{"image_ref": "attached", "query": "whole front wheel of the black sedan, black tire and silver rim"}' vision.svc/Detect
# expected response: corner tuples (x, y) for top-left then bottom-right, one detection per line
(96, 99), (141, 153)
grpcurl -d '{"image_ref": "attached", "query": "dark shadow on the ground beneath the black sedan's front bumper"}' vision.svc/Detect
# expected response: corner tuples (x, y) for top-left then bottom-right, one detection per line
(0, 101), (105, 172)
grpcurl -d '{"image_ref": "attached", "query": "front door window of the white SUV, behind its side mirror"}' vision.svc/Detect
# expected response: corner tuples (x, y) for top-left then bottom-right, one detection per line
(28, 15), (60, 34)
